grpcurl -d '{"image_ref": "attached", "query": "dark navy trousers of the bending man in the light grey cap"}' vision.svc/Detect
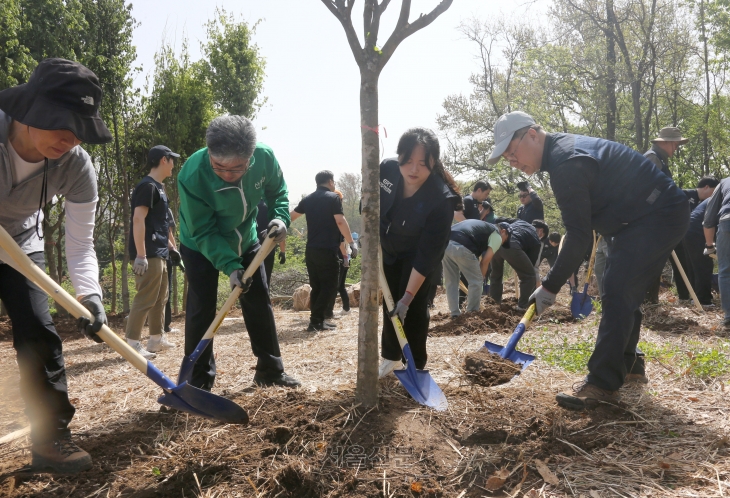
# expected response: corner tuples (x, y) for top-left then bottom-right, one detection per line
(587, 200), (689, 391)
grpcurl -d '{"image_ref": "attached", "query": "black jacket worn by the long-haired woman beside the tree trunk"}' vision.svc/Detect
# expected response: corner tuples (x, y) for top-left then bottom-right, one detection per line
(380, 158), (461, 276)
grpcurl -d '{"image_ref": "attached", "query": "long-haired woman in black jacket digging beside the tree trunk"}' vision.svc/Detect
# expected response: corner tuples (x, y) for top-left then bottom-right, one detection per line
(378, 128), (461, 377)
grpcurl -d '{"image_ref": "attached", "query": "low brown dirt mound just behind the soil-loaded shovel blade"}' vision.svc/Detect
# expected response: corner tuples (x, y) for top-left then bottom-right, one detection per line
(428, 297), (522, 336)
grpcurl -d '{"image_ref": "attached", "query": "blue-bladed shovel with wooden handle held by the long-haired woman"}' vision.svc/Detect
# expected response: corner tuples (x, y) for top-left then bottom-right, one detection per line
(380, 252), (449, 411)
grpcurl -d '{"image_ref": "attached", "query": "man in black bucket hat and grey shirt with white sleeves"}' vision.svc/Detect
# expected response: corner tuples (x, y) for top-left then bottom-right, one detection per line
(0, 59), (112, 473)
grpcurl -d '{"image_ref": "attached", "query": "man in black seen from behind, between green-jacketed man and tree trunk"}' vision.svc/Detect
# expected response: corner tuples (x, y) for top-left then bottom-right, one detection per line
(291, 170), (357, 332)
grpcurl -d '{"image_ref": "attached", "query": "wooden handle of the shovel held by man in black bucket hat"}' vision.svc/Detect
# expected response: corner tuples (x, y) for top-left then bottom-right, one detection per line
(0, 226), (175, 392)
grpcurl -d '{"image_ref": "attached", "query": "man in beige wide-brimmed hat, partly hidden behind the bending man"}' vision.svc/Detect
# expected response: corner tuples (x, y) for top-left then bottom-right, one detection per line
(644, 126), (690, 304)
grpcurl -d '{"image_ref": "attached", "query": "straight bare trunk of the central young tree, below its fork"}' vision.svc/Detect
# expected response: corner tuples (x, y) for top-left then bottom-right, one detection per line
(356, 67), (380, 407)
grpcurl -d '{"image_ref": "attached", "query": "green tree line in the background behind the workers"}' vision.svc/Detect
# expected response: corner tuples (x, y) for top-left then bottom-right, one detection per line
(0, 0), (730, 313)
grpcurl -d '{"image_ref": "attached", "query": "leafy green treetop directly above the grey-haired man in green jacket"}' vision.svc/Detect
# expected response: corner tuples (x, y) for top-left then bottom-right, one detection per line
(202, 9), (266, 118)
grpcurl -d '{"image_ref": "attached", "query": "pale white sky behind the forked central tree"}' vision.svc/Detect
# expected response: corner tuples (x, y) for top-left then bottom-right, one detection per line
(132, 0), (536, 204)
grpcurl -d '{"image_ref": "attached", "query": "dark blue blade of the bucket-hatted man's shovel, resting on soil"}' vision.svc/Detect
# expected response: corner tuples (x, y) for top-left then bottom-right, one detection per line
(157, 382), (248, 425)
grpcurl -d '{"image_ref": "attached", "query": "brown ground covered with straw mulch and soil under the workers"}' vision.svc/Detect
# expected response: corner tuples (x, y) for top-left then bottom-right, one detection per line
(0, 280), (730, 498)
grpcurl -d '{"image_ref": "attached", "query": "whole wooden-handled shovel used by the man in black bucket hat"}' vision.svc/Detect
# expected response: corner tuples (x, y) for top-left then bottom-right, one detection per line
(0, 226), (248, 424)
